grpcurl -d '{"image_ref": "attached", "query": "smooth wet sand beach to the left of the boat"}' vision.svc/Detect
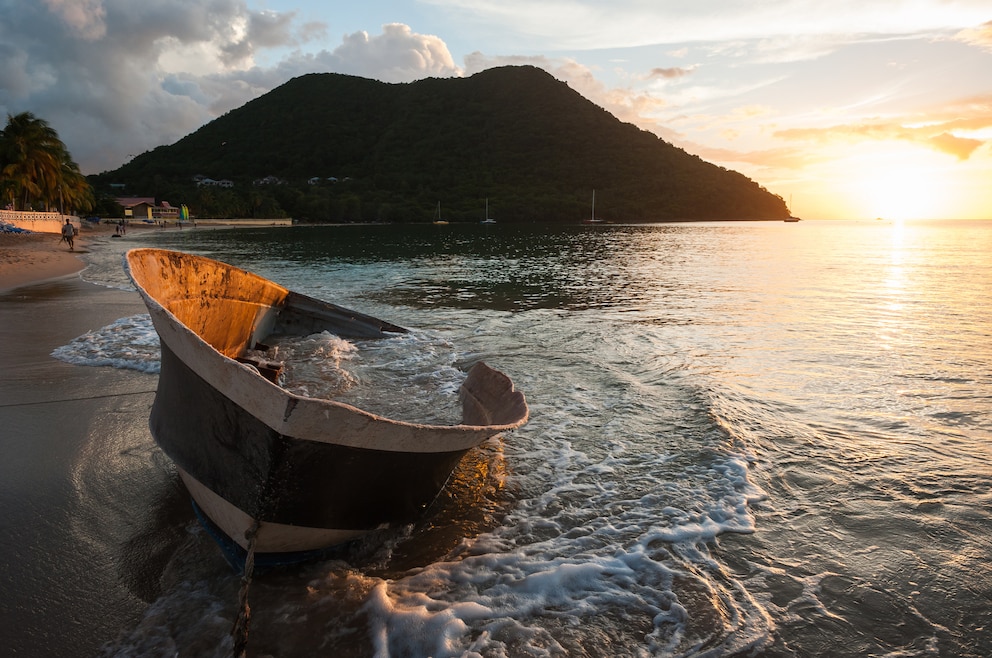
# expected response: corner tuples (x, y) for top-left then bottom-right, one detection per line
(0, 229), (191, 656)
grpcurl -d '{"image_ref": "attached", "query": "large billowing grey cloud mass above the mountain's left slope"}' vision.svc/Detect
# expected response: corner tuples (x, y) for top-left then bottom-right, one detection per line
(0, 0), (461, 173)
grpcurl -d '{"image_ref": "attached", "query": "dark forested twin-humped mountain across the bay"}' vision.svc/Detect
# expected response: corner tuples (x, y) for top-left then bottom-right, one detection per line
(93, 66), (789, 222)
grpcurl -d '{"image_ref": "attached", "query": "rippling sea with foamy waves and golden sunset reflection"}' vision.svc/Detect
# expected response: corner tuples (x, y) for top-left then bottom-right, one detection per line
(55, 221), (992, 658)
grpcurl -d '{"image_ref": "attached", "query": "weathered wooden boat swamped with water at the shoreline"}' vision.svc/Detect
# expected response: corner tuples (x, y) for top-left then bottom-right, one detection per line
(124, 249), (528, 563)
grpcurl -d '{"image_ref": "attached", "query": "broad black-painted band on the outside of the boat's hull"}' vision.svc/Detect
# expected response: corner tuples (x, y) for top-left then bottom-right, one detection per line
(150, 338), (467, 550)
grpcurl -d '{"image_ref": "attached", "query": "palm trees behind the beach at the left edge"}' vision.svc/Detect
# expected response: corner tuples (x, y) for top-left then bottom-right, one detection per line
(0, 112), (94, 213)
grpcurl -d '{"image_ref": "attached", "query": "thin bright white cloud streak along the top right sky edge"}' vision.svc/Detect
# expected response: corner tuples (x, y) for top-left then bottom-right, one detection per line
(422, 0), (988, 50)
